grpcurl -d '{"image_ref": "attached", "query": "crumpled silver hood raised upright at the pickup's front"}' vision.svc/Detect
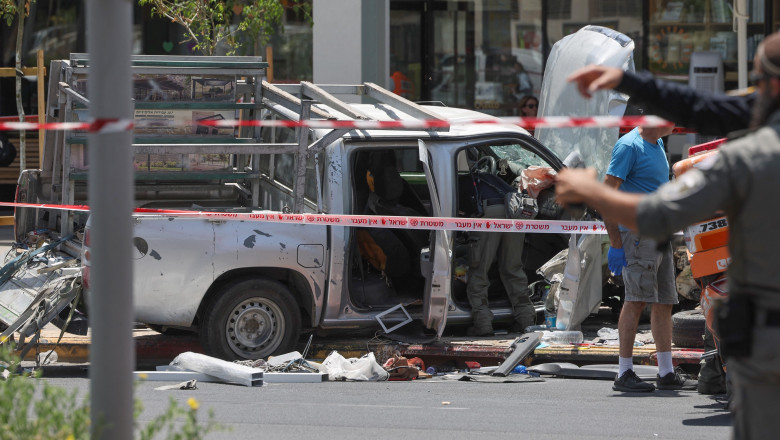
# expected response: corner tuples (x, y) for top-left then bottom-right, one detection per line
(535, 26), (634, 177)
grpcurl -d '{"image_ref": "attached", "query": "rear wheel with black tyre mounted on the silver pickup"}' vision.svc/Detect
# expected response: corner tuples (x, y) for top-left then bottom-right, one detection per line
(199, 278), (301, 360)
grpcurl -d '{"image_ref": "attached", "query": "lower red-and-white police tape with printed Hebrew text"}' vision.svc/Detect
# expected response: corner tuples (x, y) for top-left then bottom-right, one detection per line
(0, 202), (607, 234)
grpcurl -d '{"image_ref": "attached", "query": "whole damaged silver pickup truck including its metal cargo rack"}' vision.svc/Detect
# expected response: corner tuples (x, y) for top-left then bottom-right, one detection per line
(12, 27), (633, 359)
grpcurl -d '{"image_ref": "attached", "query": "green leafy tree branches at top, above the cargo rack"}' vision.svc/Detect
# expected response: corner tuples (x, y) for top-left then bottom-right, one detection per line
(139, 0), (311, 55)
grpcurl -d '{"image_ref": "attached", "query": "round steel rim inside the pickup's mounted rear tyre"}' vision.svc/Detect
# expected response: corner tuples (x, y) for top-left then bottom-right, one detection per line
(226, 298), (284, 356)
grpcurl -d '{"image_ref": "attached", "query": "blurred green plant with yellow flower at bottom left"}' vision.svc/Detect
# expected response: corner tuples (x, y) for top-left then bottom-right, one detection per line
(0, 345), (222, 440)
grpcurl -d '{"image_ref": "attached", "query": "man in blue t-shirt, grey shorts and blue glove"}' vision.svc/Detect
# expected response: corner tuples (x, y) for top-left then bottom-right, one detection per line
(604, 123), (694, 392)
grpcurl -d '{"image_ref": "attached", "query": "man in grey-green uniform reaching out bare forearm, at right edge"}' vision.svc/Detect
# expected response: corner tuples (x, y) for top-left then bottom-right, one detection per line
(556, 34), (780, 439)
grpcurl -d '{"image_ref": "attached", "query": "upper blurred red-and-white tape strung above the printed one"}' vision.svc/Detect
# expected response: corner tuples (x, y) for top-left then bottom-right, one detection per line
(0, 115), (674, 133)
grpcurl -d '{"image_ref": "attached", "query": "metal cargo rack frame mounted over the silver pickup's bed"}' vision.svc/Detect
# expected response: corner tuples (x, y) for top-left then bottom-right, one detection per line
(16, 54), (447, 240)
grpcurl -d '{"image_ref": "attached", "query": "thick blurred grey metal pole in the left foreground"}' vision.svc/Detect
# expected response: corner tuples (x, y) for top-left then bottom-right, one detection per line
(87, 0), (135, 440)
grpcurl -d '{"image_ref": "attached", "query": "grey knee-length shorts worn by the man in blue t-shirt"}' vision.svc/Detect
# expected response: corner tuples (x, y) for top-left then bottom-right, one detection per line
(620, 231), (678, 304)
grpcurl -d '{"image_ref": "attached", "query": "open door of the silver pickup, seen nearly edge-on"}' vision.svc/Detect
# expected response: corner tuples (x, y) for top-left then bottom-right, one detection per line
(418, 140), (452, 337)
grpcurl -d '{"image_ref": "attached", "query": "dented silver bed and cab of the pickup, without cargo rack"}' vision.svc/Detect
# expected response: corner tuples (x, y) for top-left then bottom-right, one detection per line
(85, 93), (566, 358)
